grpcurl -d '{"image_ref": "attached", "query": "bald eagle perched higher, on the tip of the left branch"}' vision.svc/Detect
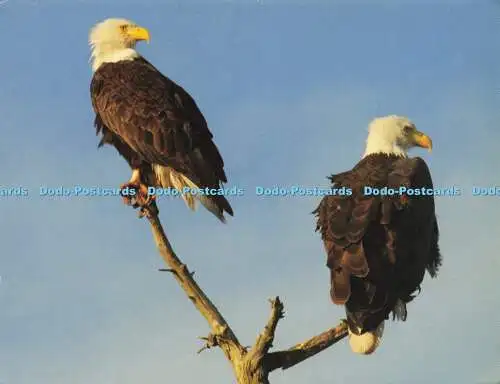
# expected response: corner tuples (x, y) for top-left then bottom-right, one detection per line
(89, 19), (233, 222)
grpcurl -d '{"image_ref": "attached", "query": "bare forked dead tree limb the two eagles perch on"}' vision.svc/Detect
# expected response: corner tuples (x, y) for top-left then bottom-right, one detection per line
(143, 204), (347, 384)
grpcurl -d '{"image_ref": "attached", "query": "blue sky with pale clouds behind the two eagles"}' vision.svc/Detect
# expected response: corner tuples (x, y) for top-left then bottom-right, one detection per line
(0, 0), (500, 384)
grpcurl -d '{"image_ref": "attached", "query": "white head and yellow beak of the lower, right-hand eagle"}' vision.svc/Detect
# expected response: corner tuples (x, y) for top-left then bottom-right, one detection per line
(363, 115), (432, 157)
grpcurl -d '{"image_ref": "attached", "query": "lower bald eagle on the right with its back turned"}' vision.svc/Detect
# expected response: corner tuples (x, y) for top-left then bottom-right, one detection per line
(313, 115), (441, 355)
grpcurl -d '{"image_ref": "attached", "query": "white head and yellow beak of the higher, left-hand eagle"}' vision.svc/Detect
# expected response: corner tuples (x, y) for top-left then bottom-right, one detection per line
(89, 19), (149, 71)
